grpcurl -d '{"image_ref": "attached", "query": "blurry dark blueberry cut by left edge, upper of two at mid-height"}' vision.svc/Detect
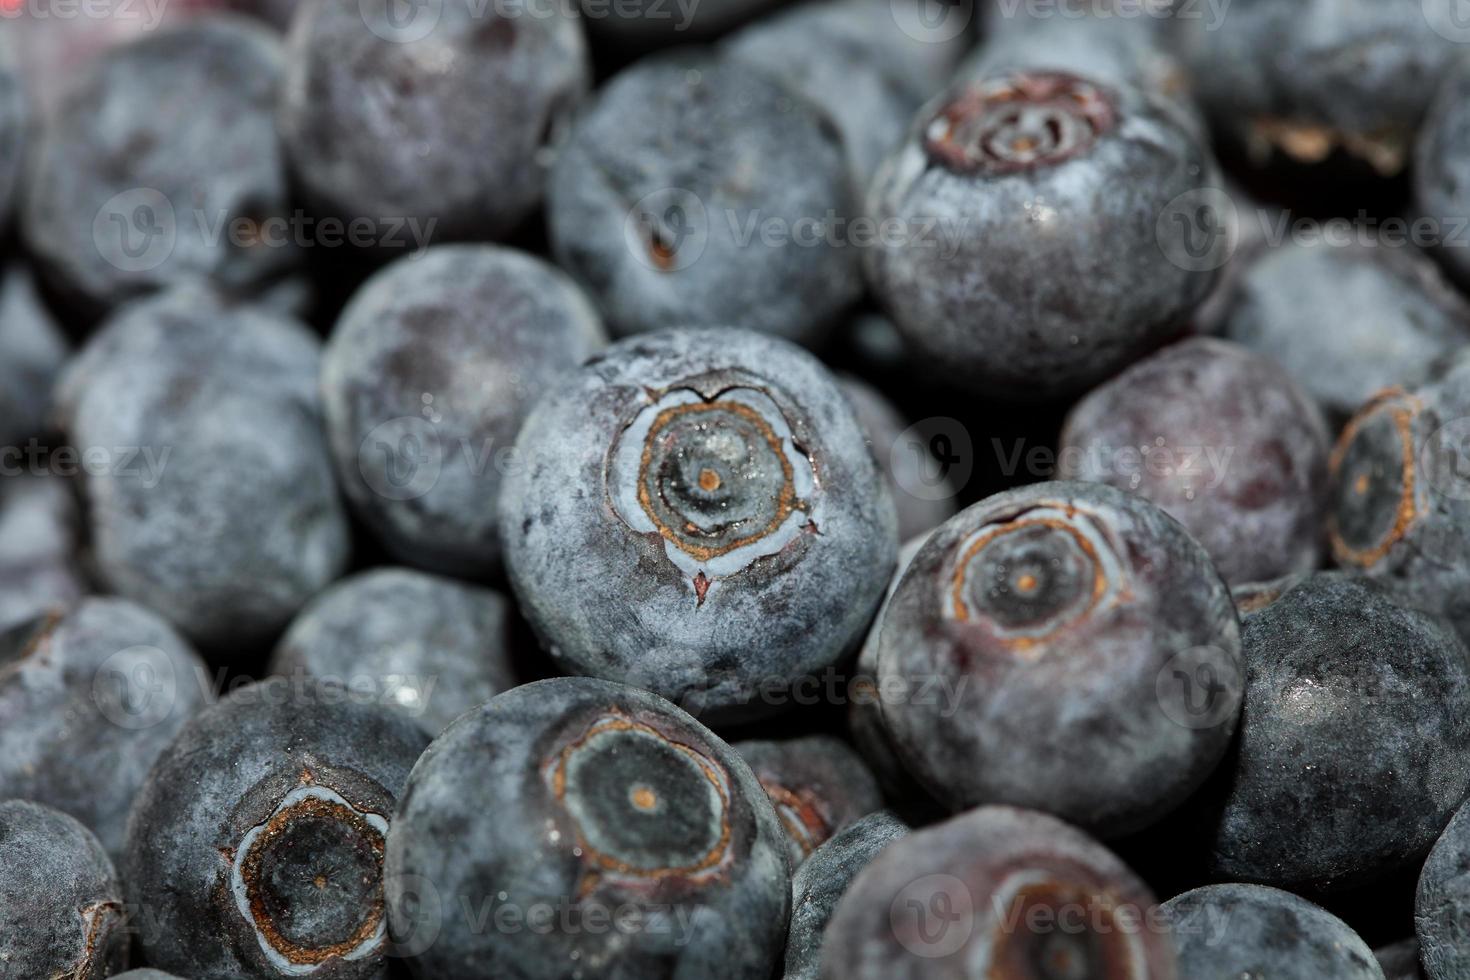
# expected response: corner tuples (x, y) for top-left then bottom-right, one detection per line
(0, 264), (68, 447)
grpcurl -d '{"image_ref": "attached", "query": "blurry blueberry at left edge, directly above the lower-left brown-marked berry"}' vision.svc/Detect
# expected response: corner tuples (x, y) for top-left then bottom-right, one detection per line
(0, 473), (87, 632)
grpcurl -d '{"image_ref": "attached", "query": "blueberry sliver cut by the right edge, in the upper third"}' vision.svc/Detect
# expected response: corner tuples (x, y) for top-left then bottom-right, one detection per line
(1414, 57), (1470, 285)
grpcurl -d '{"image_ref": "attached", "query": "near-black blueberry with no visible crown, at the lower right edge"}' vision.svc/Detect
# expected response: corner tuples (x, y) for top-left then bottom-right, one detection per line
(1204, 573), (1470, 893)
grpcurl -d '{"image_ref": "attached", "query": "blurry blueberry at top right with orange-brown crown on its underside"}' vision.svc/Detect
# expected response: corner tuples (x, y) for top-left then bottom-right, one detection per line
(1175, 0), (1464, 176)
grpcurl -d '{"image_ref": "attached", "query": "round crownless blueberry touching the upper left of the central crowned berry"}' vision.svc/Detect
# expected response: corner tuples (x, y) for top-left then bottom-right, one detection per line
(322, 245), (604, 574)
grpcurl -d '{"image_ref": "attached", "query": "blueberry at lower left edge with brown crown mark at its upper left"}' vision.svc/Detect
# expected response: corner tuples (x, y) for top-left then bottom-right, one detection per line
(0, 598), (210, 858)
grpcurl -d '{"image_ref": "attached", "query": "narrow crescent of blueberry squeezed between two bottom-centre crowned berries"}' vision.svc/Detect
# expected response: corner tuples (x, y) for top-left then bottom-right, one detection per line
(782, 810), (908, 980)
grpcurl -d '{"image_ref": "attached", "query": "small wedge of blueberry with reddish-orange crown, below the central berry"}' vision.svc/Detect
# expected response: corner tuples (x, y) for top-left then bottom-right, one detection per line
(731, 735), (883, 867)
